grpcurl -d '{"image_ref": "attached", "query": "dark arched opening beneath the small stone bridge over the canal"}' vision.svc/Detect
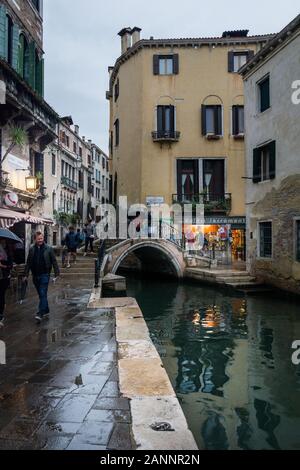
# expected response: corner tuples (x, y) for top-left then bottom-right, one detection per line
(112, 243), (183, 279)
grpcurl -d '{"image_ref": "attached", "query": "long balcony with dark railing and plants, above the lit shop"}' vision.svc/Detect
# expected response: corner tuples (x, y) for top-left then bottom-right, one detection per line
(172, 193), (232, 215)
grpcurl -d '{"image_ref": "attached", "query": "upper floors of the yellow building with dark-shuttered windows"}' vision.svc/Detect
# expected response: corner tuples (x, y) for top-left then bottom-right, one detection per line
(107, 28), (272, 264)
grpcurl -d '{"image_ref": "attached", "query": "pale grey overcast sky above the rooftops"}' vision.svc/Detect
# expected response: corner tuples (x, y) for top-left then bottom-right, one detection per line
(44, 0), (300, 152)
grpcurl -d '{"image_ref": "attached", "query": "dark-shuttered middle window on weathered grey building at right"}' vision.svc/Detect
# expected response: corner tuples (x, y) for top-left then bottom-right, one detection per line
(253, 141), (276, 183)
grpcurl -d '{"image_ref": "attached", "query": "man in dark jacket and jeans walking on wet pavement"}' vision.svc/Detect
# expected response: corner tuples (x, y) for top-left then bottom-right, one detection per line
(25, 232), (59, 323)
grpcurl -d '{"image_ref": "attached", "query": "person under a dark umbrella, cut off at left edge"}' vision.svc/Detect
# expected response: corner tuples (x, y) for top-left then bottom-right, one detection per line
(0, 229), (21, 328)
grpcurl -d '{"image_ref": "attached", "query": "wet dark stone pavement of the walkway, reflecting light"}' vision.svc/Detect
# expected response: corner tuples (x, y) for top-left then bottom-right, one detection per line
(0, 279), (133, 450)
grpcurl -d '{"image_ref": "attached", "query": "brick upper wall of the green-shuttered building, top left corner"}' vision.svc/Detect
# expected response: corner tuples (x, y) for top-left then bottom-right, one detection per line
(0, 0), (43, 50)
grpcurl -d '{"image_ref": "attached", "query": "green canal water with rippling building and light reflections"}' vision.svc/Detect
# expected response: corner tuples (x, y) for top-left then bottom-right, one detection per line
(127, 277), (300, 449)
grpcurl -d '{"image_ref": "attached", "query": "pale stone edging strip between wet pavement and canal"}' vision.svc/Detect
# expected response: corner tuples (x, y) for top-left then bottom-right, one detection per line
(116, 306), (197, 450)
